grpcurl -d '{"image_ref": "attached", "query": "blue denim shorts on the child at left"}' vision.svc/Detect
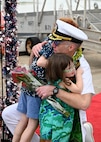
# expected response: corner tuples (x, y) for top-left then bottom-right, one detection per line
(17, 91), (41, 119)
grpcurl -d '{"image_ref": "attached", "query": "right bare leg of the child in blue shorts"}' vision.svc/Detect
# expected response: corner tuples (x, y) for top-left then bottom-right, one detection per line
(20, 118), (38, 142)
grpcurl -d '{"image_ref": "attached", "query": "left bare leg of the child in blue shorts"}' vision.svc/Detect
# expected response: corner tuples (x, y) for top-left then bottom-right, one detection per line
(12, 114), (28, 142)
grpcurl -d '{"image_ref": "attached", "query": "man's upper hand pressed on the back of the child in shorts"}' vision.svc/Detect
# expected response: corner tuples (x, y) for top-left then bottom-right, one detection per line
(32, 41), (47, 57)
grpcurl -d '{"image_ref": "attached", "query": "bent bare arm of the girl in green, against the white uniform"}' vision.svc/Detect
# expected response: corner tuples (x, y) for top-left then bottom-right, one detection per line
(65, 68), (83, 93)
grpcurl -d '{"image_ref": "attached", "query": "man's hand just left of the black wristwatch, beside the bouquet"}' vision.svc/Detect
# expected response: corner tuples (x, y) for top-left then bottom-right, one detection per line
(36, 85), (54, 99)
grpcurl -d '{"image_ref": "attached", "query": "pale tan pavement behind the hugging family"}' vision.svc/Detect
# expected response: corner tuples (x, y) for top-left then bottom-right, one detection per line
(0, 49), (101, 96)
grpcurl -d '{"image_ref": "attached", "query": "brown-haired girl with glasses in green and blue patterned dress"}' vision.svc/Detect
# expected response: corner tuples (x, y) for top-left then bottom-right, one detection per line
(39, 53), (83, 142)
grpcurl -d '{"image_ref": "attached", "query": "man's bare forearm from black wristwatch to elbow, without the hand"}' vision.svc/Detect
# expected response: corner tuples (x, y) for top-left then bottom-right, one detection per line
(57, 89), (92, 110)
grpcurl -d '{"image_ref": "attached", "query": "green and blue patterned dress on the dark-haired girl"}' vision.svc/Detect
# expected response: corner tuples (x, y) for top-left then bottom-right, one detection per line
(39, 81), (74, 142)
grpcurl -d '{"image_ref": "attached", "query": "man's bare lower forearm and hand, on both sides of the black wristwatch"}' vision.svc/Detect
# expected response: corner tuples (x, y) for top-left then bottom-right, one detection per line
(36, 85), (92, 110)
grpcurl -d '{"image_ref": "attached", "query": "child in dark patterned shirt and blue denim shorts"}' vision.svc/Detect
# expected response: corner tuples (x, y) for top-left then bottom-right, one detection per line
(12, 40), (53, 142)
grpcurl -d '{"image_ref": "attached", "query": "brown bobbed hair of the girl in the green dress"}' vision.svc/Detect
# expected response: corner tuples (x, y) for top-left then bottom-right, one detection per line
(46, 53), (73, 83)
